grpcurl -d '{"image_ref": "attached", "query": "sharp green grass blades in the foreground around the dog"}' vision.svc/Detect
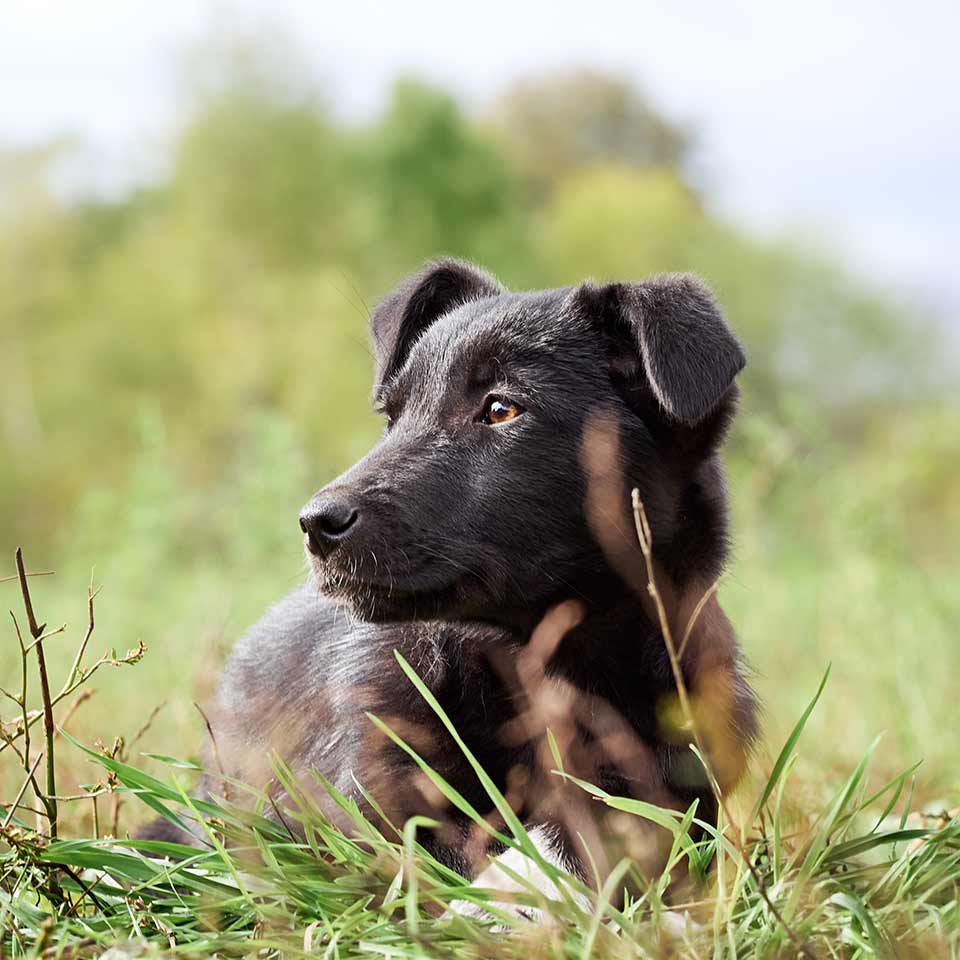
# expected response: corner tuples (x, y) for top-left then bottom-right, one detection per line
(0, 520), (960, 958)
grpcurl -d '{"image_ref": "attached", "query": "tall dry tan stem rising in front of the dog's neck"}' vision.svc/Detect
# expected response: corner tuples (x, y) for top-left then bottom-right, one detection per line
(631, 496), (814, 960)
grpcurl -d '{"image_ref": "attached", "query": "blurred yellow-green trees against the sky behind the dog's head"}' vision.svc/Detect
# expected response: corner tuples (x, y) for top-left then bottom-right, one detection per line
(0, 44), (948, 549)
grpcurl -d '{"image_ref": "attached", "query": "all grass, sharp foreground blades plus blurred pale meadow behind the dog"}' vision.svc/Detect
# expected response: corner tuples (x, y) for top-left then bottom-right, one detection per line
(0, 417), (960, 958)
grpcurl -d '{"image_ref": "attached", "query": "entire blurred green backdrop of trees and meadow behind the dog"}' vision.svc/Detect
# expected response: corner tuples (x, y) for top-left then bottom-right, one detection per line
(0, 37), (960, 800)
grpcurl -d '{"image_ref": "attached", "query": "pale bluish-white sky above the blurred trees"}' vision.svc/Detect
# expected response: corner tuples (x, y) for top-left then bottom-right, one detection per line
(0, 0), (960, 331)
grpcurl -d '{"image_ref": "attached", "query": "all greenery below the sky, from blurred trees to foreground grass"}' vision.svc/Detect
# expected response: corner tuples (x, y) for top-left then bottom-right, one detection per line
(0, 47), (960, 957)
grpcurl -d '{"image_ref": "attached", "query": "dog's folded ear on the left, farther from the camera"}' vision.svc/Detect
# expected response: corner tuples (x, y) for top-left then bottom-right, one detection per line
(370, 259), (503, 386)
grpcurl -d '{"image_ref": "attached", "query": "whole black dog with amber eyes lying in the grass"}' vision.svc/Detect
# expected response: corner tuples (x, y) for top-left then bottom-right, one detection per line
(144, 260), (755, 876)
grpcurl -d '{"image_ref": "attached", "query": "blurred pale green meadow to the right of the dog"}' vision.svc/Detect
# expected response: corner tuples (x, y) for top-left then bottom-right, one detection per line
(723, 405), (960, 796)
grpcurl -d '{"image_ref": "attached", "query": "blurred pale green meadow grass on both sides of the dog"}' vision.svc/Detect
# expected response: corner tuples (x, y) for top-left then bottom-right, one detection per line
(0, 404), (960, 804)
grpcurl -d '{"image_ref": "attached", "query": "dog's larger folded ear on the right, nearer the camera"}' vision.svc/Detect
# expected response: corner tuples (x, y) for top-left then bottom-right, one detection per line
(576, 274), (746, 426)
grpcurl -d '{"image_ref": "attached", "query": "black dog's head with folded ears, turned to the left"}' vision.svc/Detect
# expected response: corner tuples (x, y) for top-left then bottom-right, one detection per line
(300, 260), (744, 622)
